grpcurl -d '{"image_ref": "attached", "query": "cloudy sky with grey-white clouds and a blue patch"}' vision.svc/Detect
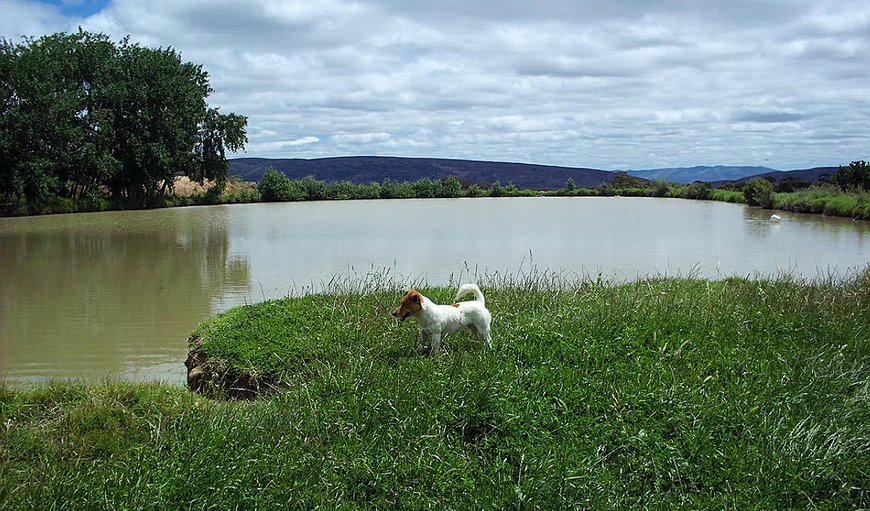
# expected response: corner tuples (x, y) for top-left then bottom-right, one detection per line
(0, 0), (870, 169)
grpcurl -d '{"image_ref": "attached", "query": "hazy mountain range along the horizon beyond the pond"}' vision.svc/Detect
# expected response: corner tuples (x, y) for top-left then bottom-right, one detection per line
(229, 156), (837, 190)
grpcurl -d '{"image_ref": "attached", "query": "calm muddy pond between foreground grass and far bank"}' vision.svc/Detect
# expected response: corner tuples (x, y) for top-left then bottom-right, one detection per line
(0, 197), (870, 383)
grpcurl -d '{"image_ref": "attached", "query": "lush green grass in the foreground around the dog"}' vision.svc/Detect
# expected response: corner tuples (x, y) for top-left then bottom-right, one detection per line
(0, 270), (870, 510)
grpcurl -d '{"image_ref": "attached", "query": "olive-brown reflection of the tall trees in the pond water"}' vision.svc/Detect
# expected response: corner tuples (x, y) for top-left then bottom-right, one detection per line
(0, 209), (249, 381)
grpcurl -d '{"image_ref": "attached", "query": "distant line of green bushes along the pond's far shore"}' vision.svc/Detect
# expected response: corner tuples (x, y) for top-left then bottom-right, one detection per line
(6, 162), (870, 220)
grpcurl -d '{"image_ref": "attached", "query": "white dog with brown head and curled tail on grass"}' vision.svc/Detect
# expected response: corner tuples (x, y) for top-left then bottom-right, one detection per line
(393, 284), (492, 355)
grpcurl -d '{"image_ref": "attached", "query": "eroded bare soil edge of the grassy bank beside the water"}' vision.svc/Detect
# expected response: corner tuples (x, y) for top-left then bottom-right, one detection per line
(184, 336), (278, 400)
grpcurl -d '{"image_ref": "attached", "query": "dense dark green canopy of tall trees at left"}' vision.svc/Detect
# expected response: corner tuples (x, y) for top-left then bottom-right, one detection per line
(0, 30), (247, 211)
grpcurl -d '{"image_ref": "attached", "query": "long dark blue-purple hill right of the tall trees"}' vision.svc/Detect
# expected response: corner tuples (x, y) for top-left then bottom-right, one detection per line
(229, 156), (614, 190)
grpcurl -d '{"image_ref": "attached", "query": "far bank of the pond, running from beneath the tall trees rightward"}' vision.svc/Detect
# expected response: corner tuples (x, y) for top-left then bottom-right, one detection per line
(0, 171), (870, 221)
